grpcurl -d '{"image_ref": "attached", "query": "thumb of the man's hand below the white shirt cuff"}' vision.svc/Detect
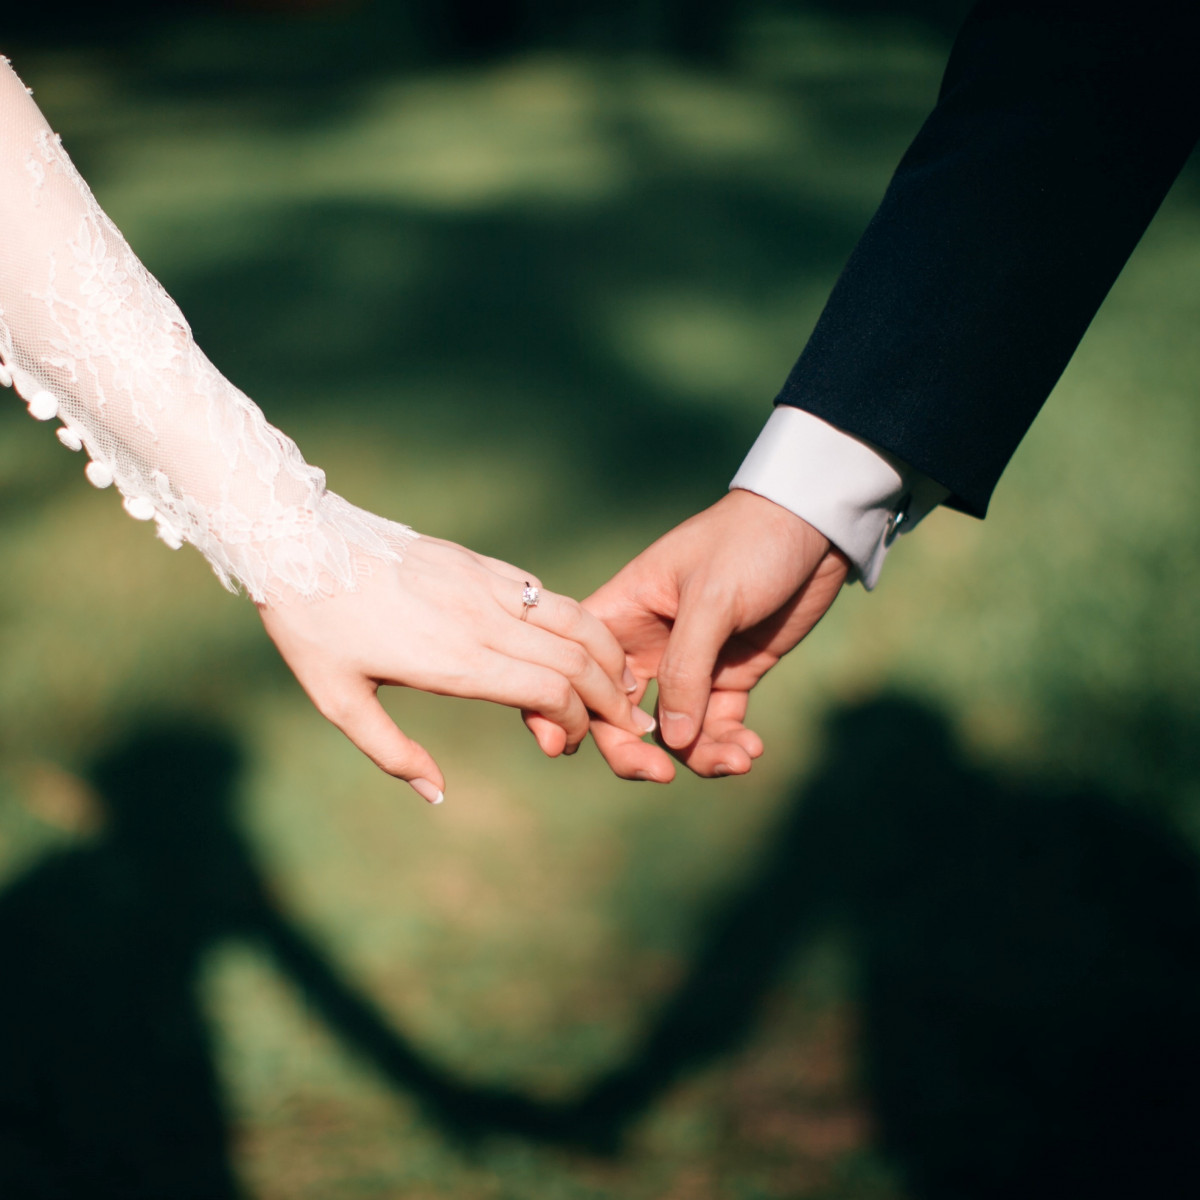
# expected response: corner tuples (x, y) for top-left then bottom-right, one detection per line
(658, 594), (733, 750)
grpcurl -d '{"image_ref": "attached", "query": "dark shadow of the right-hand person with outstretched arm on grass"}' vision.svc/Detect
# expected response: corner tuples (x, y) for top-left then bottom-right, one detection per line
(424, 697), (1200, 1200)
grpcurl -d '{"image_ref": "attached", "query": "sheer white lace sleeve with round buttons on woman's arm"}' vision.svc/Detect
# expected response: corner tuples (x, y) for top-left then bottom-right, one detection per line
(0, 59), (416, 602)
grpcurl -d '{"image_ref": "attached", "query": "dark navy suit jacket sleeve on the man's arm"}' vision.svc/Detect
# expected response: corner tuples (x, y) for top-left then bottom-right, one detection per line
(776, 0), (1200, 517)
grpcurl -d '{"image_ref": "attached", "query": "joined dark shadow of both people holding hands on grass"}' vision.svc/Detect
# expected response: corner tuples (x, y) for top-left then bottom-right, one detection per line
(0, 696), (1200, 1200)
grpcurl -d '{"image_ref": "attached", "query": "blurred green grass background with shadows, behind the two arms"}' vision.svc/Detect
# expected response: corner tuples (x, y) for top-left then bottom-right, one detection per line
(0, 0), (1200, 1200)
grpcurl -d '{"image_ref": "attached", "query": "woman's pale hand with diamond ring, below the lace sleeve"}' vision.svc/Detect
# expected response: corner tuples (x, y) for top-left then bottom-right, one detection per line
(259, 536), (654, 804)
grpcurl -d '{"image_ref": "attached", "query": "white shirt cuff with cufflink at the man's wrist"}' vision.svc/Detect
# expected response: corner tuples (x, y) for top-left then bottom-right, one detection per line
(730, 404), (949, 590)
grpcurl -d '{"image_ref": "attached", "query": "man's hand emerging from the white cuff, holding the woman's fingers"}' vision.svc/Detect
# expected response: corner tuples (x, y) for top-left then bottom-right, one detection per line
(583, 491), (850, 784)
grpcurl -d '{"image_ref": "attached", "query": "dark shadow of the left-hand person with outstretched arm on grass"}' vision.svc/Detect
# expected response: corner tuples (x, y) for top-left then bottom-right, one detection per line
(0, 724), (549, 1200)
